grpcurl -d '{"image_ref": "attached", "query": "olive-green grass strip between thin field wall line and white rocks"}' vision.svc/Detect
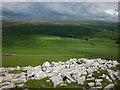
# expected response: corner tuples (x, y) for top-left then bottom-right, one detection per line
(2, 55), (96, 67)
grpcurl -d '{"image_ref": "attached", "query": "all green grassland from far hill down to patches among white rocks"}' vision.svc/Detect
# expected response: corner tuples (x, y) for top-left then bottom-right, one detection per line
(2, 20), (119, 89)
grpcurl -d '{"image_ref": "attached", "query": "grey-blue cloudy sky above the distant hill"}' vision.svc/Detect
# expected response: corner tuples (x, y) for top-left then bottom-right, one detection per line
(0, 2), (119, 22)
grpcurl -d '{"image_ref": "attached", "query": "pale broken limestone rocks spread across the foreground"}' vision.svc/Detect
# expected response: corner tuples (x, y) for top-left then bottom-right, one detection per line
(0, 58), (120, 89)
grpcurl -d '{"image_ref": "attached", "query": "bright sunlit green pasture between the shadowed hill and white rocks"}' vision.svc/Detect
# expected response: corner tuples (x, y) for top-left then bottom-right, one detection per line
(2, 35), (118, 67)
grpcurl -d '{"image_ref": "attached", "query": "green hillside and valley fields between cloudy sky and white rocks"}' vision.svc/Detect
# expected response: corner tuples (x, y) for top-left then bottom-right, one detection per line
(3, 21), (118, 66)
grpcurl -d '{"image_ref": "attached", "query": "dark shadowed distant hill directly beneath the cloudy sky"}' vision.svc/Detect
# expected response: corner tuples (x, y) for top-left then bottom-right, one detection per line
(2, 20), (118, 39)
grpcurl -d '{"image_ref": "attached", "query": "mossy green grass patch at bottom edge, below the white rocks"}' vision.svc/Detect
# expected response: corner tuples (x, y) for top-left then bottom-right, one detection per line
(15, 78), (90, 89)
